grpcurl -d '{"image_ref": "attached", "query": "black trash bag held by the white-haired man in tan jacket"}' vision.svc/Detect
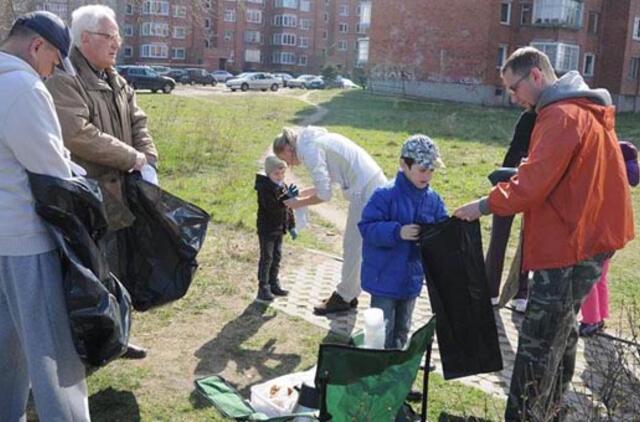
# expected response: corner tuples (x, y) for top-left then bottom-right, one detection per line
(123, 172), (210, 311)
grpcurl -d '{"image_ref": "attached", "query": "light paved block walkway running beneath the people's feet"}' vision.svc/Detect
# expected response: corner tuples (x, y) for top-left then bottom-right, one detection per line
(272, 251), (640, 421)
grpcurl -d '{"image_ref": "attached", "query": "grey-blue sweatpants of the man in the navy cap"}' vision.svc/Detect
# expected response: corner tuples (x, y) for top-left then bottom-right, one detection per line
(0, 250), (90, 422)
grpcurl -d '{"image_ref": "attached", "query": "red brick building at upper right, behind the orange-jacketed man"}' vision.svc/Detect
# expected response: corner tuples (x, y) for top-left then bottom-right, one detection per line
(368, 0), (640, 110)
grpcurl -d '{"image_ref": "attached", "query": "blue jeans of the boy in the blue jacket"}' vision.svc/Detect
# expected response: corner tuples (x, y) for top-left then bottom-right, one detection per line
(371, 296), (416, 349)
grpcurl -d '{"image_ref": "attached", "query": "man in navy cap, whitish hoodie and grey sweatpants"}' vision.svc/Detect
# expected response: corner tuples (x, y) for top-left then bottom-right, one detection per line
(0, 12), (90, 421)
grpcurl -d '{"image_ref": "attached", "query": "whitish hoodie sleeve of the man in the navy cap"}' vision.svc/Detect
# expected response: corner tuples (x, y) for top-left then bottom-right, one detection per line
(2, 87), (71, 179)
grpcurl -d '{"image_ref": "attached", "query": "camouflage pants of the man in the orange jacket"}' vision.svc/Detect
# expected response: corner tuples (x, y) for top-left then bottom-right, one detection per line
(505, 254), (610, 421)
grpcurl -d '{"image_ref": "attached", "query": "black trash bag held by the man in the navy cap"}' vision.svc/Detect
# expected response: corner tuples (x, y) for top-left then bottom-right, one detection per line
(29, 173), (131, 367)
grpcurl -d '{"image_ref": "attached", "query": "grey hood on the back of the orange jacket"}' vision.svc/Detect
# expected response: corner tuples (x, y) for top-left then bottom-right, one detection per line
(536, 70), (612, 112)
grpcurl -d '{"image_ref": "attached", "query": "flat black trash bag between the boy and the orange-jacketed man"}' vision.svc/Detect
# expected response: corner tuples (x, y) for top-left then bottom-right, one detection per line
(420, 218), (502, 379)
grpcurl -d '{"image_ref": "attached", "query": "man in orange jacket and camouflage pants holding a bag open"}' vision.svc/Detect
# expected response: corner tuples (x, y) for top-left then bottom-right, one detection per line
(454, 47), (634, 421)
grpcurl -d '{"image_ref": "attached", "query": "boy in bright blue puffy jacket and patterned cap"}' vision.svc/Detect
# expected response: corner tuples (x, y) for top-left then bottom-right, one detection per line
(358, 135), (448, 349)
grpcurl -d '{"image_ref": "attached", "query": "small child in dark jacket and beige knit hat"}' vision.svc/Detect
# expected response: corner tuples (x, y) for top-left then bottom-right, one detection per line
(255, 155), (298, 301)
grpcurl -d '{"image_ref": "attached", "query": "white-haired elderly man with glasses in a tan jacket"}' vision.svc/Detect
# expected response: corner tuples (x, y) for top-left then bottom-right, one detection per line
(46, 5), (158, 359)
